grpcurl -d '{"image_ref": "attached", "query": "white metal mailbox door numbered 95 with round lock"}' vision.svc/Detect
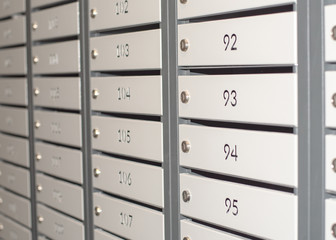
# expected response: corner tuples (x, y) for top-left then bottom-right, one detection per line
(180, 174), (298, 239)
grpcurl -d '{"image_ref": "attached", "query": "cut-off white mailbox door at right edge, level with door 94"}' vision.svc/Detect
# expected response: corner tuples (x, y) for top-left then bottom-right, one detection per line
(325, 135), (336, 192)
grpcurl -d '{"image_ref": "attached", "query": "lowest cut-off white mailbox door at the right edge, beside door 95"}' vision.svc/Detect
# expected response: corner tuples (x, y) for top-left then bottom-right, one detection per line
(325, 199), (336, 240)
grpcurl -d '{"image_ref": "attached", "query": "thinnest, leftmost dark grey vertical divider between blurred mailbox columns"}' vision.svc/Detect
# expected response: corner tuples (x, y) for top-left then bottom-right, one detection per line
(26, 0), (38, 239)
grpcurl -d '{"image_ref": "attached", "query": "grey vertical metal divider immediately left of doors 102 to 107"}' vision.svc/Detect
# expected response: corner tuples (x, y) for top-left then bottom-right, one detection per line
(79, 0), (94, 240)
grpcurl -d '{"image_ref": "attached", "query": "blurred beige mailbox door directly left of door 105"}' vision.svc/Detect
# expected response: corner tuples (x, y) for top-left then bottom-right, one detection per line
(34, 110), (82, 147)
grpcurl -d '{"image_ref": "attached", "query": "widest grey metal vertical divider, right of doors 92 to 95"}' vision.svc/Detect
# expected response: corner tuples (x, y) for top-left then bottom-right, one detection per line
(297, 0), (325, 240)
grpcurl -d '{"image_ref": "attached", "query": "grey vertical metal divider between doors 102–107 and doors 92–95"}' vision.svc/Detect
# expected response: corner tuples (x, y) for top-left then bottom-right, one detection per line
(161, 0), (180, 240)
